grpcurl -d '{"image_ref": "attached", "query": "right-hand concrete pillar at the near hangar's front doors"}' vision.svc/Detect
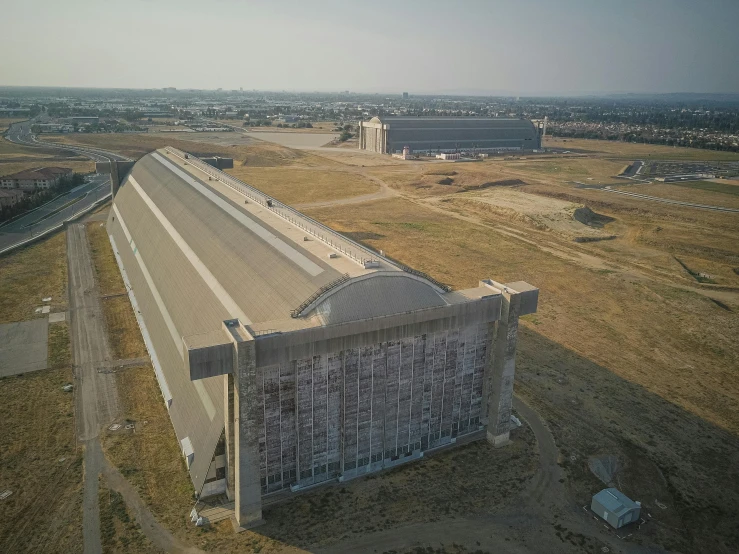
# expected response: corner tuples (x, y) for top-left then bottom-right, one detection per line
(485, 291), (521, 446)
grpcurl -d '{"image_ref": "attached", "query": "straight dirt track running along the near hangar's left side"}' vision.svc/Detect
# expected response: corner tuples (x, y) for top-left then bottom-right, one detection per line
(67, 224), (118, 554)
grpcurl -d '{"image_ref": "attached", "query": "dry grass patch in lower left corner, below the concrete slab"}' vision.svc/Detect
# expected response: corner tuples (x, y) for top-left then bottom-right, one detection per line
(0, 366), (82, 553)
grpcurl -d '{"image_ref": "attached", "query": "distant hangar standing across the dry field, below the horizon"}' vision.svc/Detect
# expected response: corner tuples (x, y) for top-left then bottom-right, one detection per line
(358, 116), (541, 154)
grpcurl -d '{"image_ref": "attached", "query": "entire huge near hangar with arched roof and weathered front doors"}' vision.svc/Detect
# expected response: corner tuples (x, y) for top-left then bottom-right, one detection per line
(107, 148), (538, 527)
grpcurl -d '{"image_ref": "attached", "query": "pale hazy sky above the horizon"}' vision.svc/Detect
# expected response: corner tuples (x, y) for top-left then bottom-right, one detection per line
(0, 0), (739, 95)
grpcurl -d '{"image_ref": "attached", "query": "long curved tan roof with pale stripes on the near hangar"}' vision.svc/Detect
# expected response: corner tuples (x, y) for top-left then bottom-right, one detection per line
(108, 148), (465, 490)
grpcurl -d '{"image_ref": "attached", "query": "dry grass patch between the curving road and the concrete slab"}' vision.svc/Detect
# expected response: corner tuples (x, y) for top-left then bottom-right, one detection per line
(0, 233), (67, 323)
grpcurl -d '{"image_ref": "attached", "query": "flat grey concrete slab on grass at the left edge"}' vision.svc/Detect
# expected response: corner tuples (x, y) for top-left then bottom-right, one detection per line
(0, 318), (49, 377)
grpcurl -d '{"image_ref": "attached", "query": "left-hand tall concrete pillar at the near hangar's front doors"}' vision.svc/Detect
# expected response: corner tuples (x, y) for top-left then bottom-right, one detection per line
(231, 325), (264, 529)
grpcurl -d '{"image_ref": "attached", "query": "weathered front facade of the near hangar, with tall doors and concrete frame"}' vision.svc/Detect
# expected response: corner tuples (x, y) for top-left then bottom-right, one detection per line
(191, 280), (538, 528)
